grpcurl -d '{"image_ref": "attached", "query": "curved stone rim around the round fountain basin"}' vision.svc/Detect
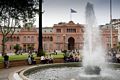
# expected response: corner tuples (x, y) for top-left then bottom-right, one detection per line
(19, 62), (120, 80)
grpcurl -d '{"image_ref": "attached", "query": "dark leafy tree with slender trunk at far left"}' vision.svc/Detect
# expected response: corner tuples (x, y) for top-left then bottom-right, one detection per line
(0, 0), (39, 55)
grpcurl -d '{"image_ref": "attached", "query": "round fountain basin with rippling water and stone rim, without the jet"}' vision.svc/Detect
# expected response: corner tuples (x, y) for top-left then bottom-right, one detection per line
(19, 63), (120, 80)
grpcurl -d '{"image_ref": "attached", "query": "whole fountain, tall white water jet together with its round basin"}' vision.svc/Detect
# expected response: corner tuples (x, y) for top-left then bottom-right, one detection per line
(17, 3), (120, 80)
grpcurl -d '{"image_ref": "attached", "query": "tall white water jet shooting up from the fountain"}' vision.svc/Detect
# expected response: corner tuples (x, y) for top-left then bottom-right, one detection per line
(83, 2), (105, 75)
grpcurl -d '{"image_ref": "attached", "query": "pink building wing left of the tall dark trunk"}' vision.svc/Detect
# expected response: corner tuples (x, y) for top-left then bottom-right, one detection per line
(0, 27), (38, 52)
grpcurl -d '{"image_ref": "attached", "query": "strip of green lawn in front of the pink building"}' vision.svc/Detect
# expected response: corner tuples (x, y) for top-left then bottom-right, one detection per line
(0, 53), (64, 63)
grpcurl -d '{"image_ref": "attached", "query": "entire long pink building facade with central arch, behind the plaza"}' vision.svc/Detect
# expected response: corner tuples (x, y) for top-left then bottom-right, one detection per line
(0, 21), (118, 53)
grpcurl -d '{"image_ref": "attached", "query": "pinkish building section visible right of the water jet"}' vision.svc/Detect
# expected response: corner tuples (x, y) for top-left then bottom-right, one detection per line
(100, 24), (118, 49)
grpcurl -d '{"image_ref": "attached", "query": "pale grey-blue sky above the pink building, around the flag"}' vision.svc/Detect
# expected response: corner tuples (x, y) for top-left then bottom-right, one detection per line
(35, 0), (120, 27)
